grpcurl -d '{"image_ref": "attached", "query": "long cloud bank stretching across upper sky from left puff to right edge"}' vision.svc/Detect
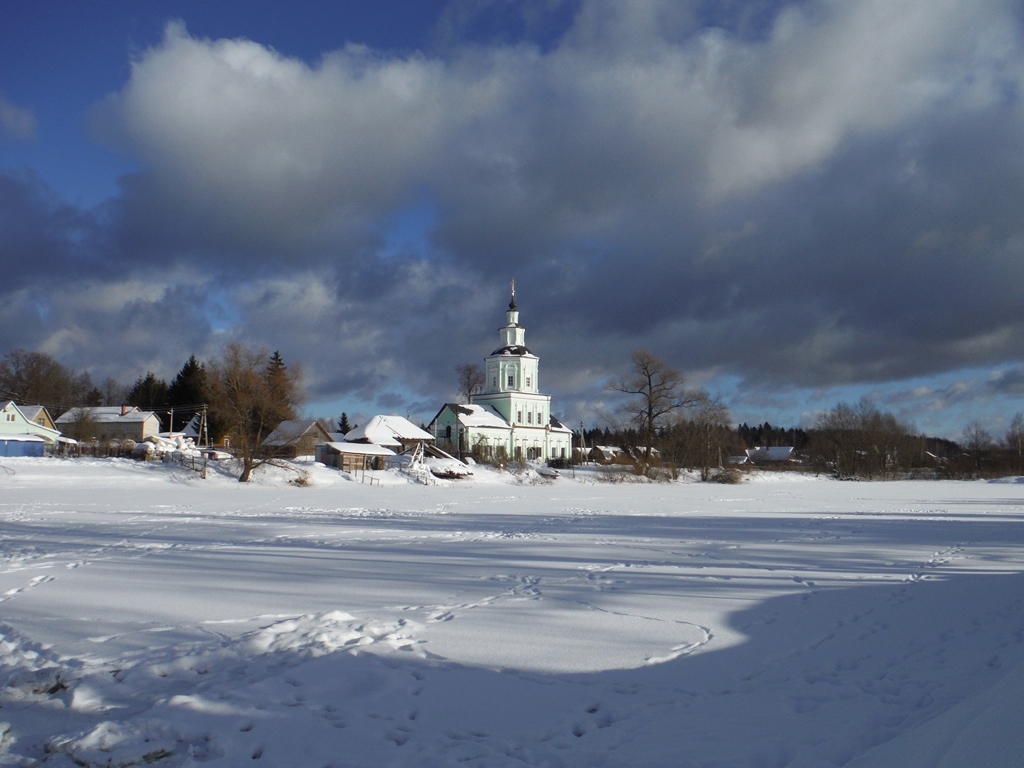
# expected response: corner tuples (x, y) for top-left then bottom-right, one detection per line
(94, 0), (1019, 252)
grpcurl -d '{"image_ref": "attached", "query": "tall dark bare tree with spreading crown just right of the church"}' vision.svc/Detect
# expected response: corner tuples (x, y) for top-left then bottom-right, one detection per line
(607, 349), (701, 473)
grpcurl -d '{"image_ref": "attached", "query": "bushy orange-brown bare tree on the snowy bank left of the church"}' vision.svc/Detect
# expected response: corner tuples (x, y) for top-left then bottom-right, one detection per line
(209, 343), (301, 482)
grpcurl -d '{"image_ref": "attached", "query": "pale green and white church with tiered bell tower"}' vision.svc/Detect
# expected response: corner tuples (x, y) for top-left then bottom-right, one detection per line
(430, 281), (572, 462)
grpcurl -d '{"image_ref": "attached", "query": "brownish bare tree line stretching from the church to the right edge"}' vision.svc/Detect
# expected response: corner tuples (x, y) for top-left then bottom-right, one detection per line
(598, 350), (1024, 480)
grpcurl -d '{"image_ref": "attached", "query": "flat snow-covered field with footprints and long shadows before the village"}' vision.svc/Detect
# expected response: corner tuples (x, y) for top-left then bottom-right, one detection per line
(0, 459), (1024, 768)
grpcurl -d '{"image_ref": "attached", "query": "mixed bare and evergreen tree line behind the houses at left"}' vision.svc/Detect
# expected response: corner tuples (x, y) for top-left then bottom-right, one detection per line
(0, 342), (303, 482)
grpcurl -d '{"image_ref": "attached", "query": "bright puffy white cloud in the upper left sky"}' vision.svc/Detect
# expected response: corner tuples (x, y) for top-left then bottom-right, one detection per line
(105, 25), (450, 252)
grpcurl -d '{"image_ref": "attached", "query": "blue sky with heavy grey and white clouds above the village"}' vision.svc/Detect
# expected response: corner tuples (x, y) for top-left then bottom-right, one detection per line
(0, 0), (1024, 438)
